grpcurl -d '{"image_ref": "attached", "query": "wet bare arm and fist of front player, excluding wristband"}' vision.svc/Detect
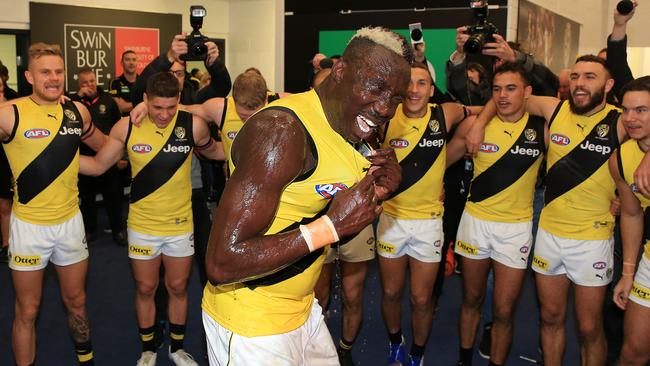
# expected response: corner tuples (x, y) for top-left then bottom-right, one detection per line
(206, 110), (377, 283)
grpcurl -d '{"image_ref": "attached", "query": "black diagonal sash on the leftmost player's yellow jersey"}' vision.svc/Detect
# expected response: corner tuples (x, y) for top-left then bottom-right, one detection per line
(13, 102), (83, 204)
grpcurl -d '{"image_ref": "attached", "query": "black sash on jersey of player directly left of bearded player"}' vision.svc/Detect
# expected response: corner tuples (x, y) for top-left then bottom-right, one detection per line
(467, 116), (545, 202)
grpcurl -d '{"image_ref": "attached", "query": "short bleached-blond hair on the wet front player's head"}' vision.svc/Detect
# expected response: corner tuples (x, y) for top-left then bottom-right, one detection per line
(343, 27), (414, 64)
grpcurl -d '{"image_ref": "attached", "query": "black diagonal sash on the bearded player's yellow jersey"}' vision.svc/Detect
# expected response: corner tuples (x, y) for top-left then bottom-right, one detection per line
(544, 110), (619, 205)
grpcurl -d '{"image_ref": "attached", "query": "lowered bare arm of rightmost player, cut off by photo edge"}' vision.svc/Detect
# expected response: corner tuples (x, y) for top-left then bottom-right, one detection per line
(609, 151), (644, 309)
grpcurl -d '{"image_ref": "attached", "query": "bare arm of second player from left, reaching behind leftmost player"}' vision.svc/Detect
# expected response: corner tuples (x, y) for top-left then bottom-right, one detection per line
(79, 117), (129, 176)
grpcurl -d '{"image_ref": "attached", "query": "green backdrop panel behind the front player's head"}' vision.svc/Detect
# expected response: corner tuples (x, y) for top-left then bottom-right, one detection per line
(318, 29), (456, 92)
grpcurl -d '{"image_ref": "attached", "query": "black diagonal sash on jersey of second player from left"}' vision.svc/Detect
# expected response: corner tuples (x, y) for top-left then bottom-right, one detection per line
(130, 111), (194, 203)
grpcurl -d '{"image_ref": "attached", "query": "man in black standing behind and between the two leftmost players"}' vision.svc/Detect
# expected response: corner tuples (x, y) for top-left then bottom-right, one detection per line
(72, 68), (126, 245)
